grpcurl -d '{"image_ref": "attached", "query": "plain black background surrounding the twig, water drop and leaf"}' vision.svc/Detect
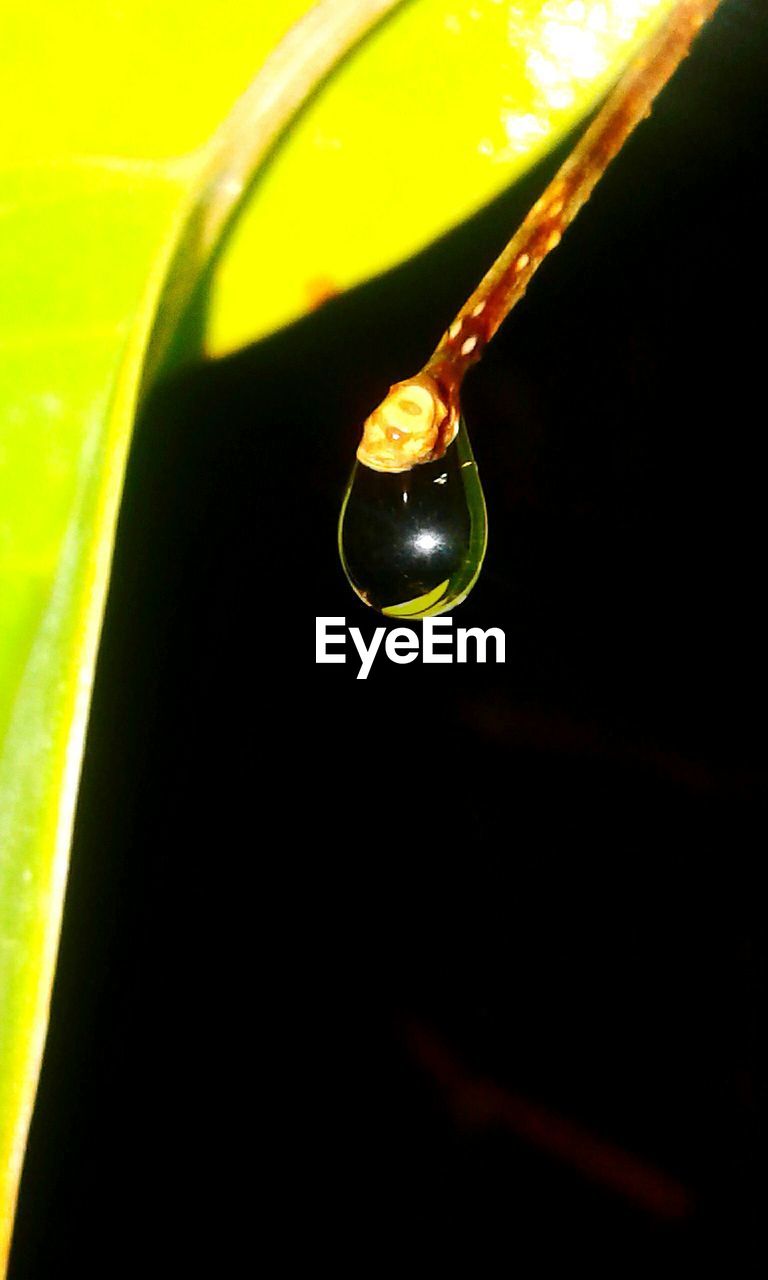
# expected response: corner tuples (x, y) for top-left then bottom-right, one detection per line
(12, 0), (768, 1280)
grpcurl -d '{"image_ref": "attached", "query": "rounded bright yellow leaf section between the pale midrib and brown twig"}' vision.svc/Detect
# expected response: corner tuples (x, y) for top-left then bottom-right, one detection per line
(209, 0), (671, 355)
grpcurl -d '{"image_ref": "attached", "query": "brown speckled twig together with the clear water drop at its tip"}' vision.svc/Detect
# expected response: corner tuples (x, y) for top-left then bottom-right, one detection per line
(339, 0), (719, 618)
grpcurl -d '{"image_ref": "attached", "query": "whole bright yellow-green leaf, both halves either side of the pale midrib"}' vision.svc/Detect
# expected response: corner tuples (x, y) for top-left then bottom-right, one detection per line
(0, 0), (669, 1268)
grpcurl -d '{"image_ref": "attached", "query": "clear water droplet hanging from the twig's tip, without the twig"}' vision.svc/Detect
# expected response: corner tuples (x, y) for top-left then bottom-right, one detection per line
(339, 420), (488, 618)
